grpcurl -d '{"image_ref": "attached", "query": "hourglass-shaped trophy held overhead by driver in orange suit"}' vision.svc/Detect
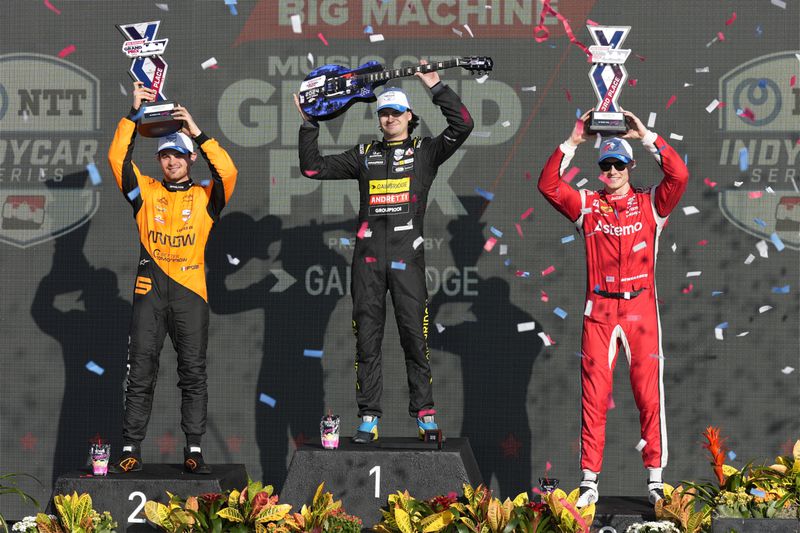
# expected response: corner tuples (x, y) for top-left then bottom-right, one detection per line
(117, 20), (183, 137)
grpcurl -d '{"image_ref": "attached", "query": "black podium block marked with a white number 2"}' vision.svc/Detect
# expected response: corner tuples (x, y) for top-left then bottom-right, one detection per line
(49, 464), (247, 533)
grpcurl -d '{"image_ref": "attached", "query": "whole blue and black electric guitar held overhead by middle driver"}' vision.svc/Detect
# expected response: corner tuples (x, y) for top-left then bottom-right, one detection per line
(297, 57), (493, 120)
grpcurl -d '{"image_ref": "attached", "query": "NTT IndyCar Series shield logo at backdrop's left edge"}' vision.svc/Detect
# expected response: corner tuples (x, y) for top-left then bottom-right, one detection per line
(0, 53), (100, 248)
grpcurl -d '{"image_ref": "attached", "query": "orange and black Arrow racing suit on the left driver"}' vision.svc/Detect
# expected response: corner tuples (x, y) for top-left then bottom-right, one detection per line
(108, 111), (237, 445)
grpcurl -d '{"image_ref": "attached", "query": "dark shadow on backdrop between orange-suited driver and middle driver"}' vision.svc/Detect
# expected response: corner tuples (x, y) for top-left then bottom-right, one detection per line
(206, 212), (355, 484)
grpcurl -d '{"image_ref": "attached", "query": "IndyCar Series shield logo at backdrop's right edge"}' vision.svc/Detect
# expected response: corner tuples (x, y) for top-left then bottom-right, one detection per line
(719, 50), (800, 250)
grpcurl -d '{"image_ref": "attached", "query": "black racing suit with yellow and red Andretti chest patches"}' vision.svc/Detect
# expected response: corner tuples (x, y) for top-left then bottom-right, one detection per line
(299, 83), (473, 417)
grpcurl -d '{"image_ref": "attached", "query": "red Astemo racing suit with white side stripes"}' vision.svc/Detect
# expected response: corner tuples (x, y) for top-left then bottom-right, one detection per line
(539, 132), (689, 473)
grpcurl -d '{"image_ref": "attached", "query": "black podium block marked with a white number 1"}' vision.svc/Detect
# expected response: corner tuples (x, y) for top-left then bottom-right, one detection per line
(280, 438), (482, 528)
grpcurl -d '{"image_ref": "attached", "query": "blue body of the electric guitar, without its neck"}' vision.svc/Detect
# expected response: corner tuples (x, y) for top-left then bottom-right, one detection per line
(297, 61), (386, 120)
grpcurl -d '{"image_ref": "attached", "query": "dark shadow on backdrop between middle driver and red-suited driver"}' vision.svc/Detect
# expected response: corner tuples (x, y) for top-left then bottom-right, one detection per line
(428, 196), (542, 497)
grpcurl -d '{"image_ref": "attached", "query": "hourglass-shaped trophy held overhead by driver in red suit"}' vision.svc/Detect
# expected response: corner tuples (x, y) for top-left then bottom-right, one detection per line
(586, 26), (631, 135)
